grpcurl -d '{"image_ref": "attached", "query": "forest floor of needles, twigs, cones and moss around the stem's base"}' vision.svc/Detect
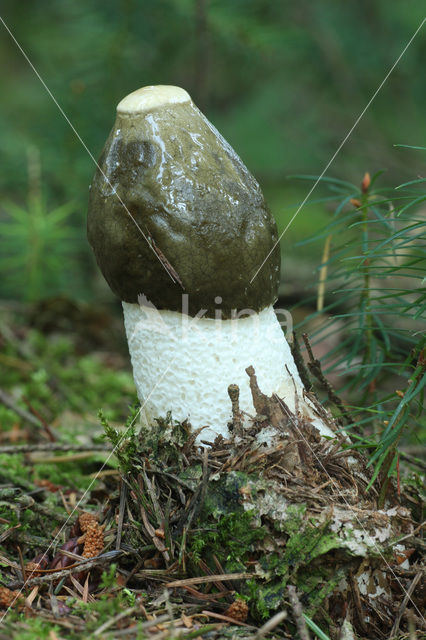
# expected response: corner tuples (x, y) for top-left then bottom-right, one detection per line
(0, 308), (426, 640)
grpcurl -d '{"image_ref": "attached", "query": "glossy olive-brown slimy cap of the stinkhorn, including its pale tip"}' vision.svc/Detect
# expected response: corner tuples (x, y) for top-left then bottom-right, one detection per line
(87, 86), (280, 318)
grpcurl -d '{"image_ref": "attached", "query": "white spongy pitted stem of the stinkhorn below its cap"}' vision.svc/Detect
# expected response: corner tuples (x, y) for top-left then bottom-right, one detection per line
(123, 302), (333, 440)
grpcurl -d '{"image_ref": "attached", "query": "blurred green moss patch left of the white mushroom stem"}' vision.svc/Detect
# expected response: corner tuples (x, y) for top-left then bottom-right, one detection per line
(0, 330), (136, 432)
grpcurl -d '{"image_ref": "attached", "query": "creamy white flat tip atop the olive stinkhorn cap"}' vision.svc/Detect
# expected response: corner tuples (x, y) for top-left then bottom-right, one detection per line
(117, 84), (191, 115)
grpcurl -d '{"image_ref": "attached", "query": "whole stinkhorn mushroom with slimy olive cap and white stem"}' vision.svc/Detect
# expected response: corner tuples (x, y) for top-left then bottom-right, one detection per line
(88, 86), (333, 438)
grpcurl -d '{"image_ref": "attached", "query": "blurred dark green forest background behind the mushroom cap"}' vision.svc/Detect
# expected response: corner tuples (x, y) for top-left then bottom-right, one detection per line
(0, 0), (426, 302)
